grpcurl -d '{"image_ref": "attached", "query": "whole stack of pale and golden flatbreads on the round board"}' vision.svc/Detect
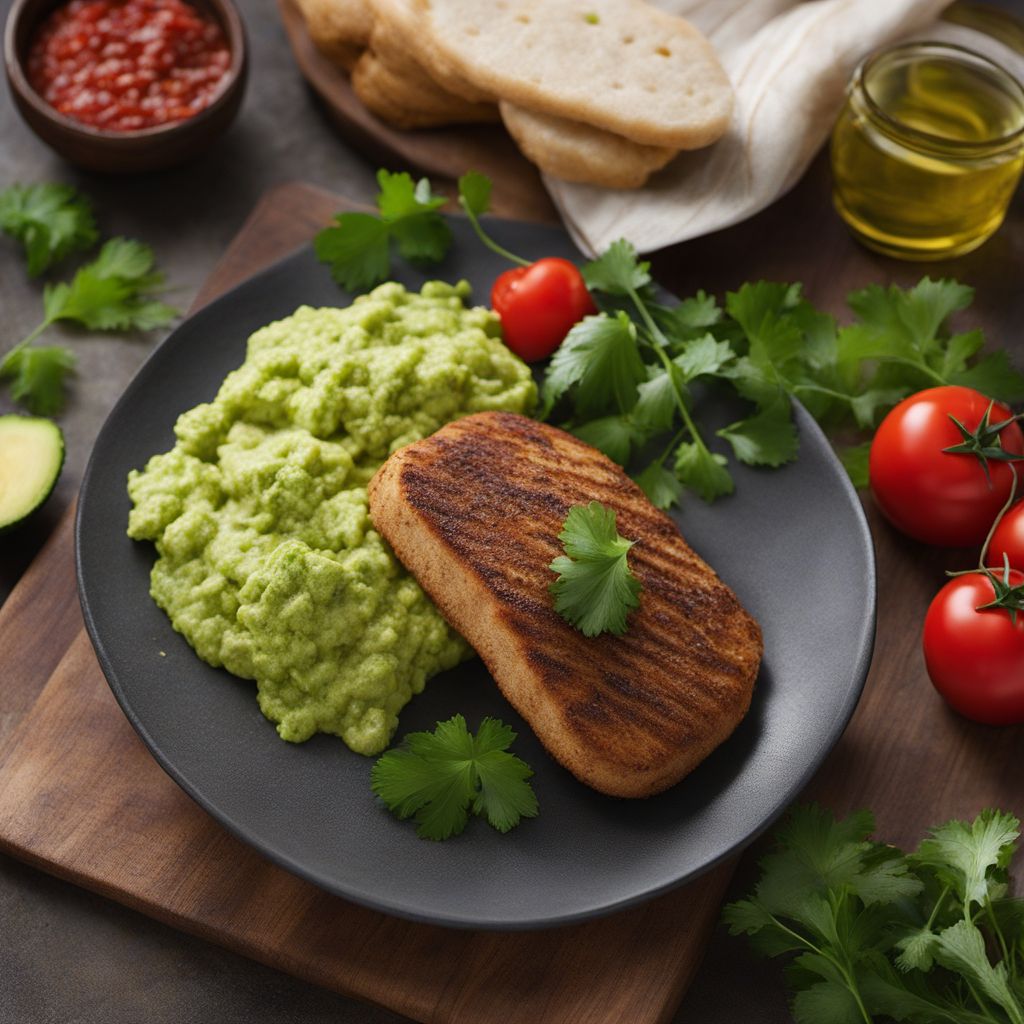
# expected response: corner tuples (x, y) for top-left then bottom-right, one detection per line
(297, 0), (732, 188)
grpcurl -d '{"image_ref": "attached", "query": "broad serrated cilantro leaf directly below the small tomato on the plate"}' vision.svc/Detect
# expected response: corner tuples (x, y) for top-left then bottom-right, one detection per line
(543, 312), (647, 417)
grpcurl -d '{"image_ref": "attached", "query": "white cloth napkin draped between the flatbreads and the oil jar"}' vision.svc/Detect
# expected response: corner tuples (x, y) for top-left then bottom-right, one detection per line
(546, 0), (991, 253)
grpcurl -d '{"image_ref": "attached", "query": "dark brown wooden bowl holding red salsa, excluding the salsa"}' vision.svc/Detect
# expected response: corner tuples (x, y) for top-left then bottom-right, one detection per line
(3, 0), (249, 173)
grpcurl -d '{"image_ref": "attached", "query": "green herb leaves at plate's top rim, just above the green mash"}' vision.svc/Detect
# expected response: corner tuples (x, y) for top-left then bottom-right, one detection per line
(313, 170), (452, 292)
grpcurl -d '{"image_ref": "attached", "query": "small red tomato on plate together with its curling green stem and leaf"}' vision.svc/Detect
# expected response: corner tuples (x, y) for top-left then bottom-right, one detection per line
(459, 171), (597, 362)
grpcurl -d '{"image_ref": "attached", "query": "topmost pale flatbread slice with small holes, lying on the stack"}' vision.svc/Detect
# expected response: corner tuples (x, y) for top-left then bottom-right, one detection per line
(411, 0), (732, 150)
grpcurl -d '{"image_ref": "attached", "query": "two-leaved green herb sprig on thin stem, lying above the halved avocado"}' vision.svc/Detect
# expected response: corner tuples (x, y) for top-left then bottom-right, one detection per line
(0, 239), (175, 416)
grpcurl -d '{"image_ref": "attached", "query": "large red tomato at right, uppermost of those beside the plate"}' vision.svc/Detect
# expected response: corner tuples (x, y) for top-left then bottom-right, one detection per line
(869, 385), (1024, 547)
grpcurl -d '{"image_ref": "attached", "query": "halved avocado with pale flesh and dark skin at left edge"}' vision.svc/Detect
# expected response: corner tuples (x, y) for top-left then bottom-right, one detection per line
(0, 416), (65, 532)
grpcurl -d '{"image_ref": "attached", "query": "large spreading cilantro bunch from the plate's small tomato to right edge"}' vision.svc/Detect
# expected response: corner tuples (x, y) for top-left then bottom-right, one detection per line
(543, 241), (1024, 508)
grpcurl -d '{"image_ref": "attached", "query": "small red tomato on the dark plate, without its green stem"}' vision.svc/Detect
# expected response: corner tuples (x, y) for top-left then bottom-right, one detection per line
(490, 256), (597, 362)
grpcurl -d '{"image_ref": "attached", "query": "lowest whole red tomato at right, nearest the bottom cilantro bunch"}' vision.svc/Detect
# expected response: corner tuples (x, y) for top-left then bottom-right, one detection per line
(924, 569), (1024, 725)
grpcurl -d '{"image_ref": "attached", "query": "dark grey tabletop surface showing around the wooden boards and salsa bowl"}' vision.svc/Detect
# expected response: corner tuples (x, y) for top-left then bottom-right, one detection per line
(0, 0), (1021, 1024)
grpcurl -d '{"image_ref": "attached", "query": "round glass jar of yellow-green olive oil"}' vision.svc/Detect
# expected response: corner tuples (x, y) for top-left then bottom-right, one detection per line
(831, 43), (1024, 259)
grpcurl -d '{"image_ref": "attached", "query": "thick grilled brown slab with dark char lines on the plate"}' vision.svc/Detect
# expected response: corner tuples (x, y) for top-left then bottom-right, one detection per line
(370, 413), (762, 797)
